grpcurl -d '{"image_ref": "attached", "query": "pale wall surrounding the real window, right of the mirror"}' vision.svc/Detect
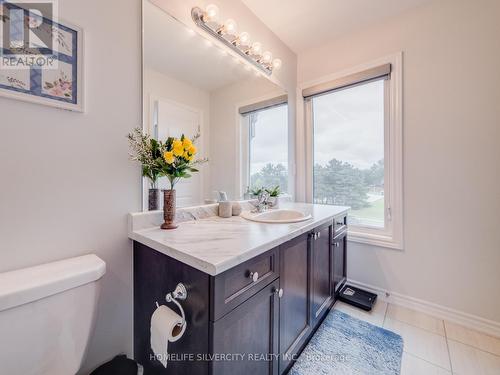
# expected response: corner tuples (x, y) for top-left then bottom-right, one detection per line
(298, 0), (500, 322)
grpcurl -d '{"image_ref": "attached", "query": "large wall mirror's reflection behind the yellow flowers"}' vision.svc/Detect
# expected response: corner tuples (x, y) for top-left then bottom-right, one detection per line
(143, 0), (289, 209)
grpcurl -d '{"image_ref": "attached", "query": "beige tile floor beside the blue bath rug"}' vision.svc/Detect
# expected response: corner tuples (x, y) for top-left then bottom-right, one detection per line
(335, 301), (500, 375)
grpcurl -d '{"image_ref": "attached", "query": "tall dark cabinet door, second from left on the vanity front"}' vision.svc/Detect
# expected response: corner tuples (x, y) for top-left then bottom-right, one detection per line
(279, 234), (311, 373)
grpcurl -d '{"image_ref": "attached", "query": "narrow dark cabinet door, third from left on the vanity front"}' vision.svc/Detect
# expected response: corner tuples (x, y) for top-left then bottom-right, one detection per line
(311, 225), (333, 325)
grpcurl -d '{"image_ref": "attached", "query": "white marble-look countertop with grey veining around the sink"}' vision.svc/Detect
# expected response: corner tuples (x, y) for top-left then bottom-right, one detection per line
(129, 203), (349, 276)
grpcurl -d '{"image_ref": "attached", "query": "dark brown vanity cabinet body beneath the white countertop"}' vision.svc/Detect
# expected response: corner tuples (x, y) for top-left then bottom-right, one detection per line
(134, 217), (347, 375)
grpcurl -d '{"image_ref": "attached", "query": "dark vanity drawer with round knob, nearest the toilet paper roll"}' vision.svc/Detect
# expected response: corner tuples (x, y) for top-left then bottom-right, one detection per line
(210, 247), (279, 321)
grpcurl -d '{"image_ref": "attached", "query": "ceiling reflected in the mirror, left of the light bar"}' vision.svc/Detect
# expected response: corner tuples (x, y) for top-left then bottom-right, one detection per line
(144, 1), (262, 91)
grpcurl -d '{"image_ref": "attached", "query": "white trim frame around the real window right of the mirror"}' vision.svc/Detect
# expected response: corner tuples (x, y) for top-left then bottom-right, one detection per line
(301, 52), (404, 250)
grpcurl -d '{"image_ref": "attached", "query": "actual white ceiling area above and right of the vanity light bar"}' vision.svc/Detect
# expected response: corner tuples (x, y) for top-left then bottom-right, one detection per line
(242, 0), (436, 53)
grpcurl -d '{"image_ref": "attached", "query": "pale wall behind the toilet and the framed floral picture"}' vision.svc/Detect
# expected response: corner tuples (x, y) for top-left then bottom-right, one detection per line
(0, 0), (141, 374)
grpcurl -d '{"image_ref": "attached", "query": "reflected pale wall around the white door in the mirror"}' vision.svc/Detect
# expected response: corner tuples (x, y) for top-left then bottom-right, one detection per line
(144, 69), (211, 198)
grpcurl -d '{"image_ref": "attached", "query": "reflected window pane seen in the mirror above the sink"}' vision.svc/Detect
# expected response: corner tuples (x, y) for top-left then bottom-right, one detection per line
(243, 104), (289, 193)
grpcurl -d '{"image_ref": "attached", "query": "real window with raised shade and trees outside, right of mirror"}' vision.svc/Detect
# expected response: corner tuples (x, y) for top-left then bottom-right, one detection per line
(303, 54), (402, 248)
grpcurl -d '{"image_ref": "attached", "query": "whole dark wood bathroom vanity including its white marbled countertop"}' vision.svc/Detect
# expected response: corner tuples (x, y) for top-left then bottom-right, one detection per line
(129, 203), (348, 375)
